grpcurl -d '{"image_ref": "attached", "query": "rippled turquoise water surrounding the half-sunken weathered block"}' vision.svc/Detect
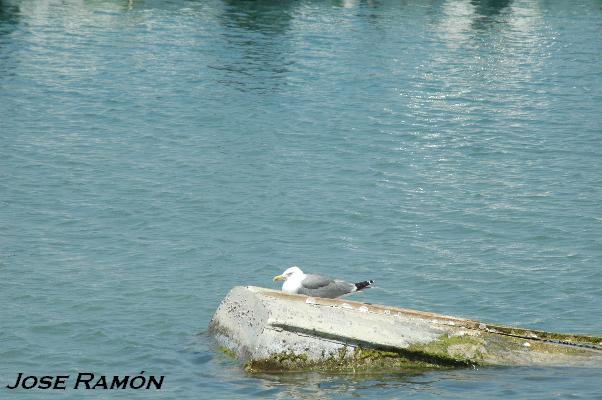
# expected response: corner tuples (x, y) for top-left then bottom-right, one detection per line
(0, 0), (602, 399)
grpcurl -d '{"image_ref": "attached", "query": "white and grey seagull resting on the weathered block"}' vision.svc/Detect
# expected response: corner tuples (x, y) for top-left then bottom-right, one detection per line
(274, 266), (374, 299)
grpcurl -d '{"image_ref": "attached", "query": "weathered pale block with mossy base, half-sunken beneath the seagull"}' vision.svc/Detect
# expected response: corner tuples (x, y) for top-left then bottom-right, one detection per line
(209, 286), (602, 371)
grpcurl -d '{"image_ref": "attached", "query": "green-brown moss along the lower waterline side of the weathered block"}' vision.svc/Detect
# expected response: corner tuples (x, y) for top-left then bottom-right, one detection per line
(220, 333), (591, 374)
